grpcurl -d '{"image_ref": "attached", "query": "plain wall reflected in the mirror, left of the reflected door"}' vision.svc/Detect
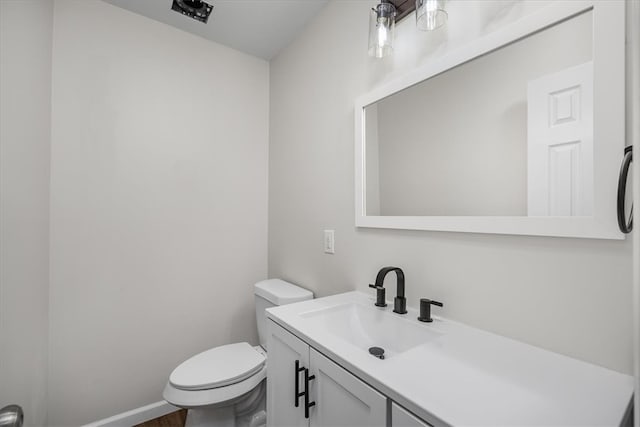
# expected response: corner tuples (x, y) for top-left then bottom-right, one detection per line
(376, 13), (593, 216)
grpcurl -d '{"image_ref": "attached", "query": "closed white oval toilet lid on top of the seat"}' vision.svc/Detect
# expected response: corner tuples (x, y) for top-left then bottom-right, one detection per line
(169, 342), (266, 390)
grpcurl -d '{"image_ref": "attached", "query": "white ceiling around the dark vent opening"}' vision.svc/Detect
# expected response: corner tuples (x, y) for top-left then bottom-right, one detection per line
(104, 0), (328, 60)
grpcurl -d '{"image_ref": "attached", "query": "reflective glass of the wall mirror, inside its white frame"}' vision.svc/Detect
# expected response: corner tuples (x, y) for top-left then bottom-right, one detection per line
(363, 11), (594, 217)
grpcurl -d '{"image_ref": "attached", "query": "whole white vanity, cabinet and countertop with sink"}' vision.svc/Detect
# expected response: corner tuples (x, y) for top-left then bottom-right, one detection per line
(267, 291), (634, 427)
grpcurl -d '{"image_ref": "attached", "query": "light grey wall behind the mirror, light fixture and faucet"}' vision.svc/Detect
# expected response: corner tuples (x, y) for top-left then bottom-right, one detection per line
(269, 0), (632, 373)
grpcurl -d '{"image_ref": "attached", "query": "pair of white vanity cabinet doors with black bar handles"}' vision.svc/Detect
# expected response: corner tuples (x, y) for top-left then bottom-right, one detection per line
(267, 321), (387, 427)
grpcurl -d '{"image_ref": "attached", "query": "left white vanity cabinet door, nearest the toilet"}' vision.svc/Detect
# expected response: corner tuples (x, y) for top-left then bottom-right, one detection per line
(267, 320), (309, 427)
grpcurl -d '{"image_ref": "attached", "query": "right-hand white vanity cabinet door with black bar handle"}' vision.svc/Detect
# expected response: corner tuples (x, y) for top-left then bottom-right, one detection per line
(309, 349), (387, 427)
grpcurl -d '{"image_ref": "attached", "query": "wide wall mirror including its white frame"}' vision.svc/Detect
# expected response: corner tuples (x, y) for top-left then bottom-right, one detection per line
(356, 2), (624, 238)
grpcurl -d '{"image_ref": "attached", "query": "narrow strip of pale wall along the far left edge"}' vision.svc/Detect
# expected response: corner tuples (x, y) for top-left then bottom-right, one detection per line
(0, 0), (53, 425)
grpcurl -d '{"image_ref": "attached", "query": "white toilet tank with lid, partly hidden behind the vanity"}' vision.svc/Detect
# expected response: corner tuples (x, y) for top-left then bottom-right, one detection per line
(253, 279), (313, 350)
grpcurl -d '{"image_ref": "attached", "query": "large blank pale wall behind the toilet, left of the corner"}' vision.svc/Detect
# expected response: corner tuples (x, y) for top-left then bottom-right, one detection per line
(48, 0), (269, 426)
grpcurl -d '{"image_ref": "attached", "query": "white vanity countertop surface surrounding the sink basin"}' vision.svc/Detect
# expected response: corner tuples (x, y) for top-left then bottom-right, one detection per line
(267, 292), (633, 426)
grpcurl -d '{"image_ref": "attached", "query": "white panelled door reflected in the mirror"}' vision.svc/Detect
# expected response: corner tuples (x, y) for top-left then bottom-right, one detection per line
(527, 62), (594, 216)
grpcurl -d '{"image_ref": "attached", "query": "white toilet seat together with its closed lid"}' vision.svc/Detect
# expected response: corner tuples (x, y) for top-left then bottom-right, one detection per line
(162, 343), (267, 408)
